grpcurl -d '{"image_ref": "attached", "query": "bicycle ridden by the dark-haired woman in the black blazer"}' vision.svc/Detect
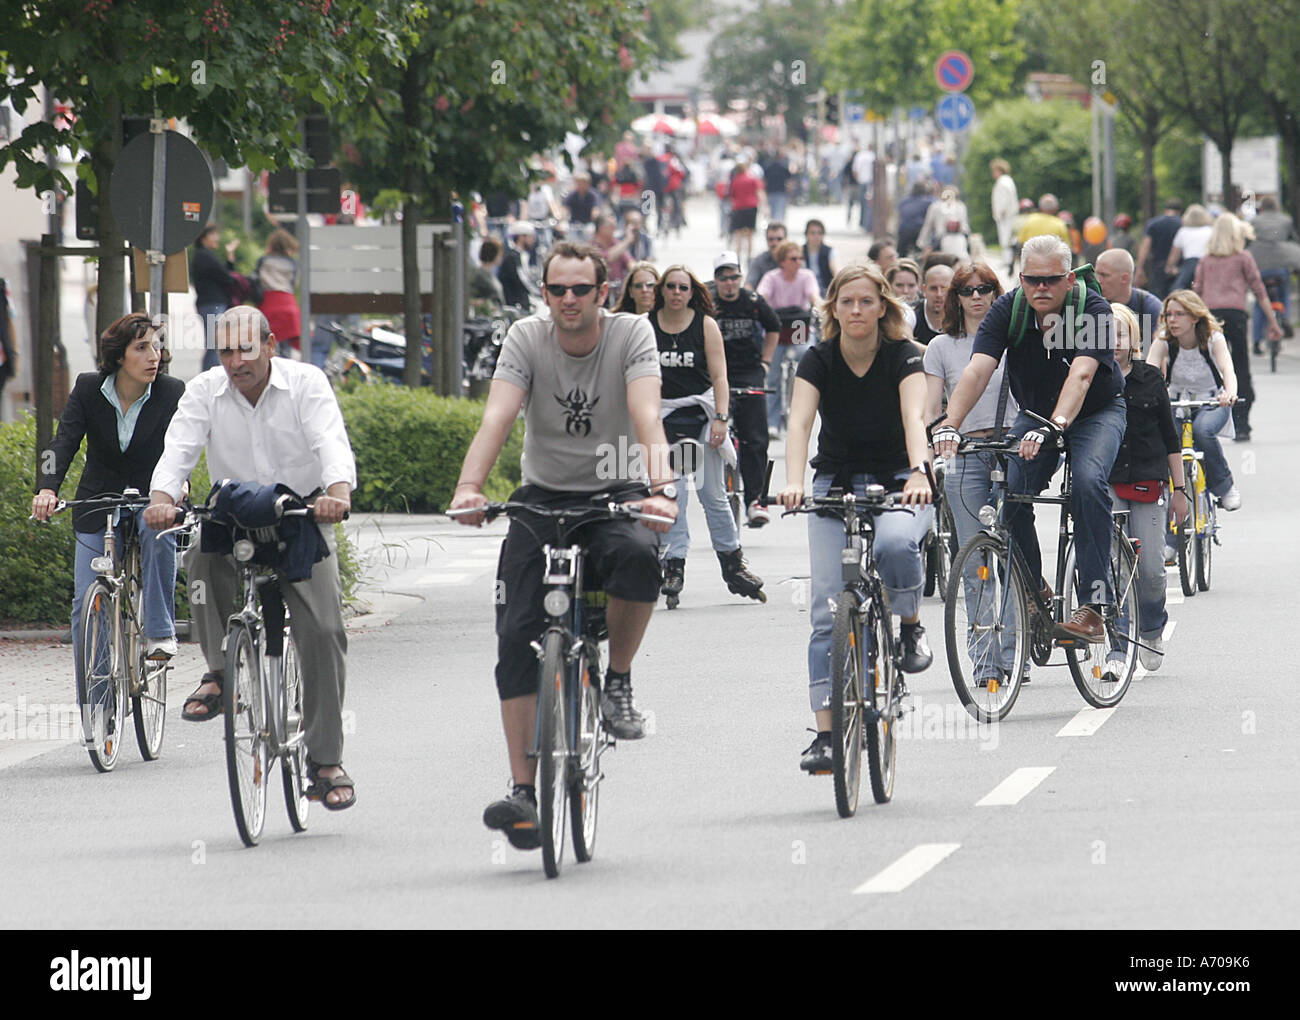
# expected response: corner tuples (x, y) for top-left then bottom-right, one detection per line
(34, 489), (172, 772)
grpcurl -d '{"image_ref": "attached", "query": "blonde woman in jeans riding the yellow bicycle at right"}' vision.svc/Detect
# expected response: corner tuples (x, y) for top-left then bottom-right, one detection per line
(1147, 291), (1242, 511)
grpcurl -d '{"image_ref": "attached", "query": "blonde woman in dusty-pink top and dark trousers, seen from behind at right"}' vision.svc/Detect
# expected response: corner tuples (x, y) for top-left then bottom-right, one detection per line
(1192, 213), (1282, 443)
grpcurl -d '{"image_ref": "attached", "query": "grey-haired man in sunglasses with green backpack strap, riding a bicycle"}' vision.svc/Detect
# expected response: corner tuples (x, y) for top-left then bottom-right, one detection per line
(933, 235), (1127, 643)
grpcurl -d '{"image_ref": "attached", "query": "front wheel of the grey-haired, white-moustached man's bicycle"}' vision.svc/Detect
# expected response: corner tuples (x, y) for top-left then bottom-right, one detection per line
(944, 531), (1030, 722)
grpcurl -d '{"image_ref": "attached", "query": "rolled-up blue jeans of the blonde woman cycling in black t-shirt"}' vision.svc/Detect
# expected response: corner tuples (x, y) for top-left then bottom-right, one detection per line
(809, 472), (935, 712)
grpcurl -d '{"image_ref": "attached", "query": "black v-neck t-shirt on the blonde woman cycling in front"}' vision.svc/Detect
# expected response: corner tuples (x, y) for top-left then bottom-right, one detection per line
(797, 339), (923, 479)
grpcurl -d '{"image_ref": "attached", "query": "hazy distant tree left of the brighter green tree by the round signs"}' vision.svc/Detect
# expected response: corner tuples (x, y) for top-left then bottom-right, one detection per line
(706, 0), (835, 138)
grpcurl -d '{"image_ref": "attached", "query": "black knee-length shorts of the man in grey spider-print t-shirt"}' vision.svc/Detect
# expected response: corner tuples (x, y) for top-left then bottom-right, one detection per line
(497, 485), (663, 700)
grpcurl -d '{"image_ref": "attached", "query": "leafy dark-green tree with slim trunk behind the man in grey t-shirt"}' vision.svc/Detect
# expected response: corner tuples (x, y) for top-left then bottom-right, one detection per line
(343, 0), (653, 385)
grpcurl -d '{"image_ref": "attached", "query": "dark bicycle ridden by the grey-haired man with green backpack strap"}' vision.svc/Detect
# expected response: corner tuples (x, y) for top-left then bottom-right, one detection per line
(944, 412), (1141, 722)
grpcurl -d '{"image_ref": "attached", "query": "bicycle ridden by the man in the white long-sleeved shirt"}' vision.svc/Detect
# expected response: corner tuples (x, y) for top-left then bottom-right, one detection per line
(159, 494), (313, 847)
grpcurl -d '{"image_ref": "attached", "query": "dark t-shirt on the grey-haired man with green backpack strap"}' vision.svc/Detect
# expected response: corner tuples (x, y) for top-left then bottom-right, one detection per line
(971, 290), (1125, 418)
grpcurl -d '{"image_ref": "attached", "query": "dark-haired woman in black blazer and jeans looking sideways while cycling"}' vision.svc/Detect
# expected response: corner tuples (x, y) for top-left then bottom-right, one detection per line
(31, 312), (185, 663)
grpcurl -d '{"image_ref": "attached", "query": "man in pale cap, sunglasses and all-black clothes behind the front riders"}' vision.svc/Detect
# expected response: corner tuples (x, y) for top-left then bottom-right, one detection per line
(709, 252), (781, 528)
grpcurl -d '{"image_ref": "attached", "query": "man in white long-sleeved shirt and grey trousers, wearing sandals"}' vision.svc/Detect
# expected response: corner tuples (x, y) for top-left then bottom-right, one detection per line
(144, 305), (356, 811)
